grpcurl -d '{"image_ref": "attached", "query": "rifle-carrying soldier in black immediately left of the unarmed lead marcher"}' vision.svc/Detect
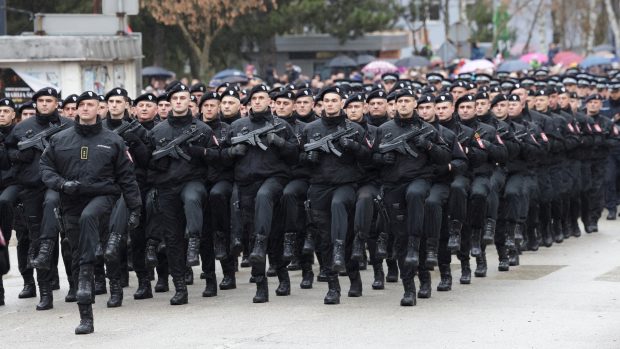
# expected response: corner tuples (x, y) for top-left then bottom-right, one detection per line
(5, 88), (73, 310)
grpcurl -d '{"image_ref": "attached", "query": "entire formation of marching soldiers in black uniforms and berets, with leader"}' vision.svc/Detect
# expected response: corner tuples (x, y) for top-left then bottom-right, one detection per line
(0, 69), (620, 334)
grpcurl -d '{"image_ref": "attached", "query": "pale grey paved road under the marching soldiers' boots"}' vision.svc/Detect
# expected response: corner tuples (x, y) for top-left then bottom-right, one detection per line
(0, 216), (620, 349)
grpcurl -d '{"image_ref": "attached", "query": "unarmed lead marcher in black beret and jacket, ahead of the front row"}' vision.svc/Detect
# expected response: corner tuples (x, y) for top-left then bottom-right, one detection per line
(41, 91), (141, 334)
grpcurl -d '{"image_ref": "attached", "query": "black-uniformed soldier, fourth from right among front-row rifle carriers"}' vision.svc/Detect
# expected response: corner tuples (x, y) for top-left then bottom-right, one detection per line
(147, 84), (215, 305)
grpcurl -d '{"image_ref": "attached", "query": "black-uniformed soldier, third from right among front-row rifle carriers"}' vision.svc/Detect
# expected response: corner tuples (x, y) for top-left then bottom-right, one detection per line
(223, 85), (298, 303)
